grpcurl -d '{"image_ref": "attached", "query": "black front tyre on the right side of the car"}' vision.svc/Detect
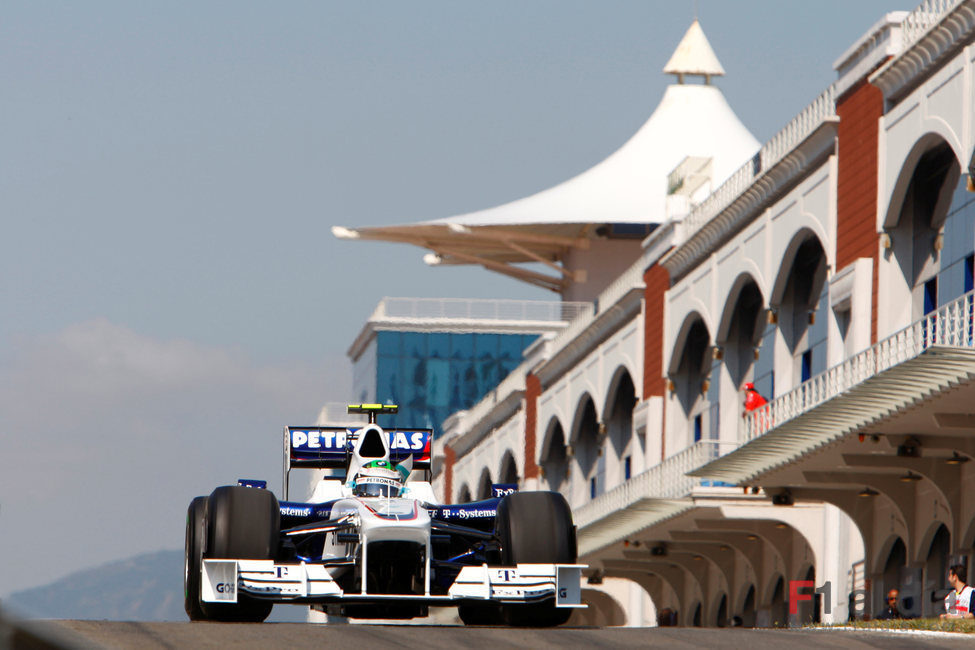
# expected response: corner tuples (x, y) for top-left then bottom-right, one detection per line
(495, 492), (577, 627)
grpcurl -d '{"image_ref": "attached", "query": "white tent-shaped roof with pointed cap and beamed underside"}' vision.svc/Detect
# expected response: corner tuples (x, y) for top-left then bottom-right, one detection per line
(332, 21), (760, 289)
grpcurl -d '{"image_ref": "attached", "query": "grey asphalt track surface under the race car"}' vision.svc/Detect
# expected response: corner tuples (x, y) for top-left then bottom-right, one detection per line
(13, 621), (975, 650)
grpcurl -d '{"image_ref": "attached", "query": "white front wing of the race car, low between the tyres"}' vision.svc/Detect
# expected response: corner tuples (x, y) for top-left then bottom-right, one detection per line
(200, 560), (586, 607)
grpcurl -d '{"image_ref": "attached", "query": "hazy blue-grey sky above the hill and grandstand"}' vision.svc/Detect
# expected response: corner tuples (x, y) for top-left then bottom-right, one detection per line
(0, 0), (913, 596)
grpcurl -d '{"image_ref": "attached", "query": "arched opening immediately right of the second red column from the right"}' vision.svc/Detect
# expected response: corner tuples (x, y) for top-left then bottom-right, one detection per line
(670, 314), (711, 444)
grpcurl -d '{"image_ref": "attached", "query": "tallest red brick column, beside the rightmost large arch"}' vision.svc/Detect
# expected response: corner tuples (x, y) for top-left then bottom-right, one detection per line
(836, 79), (884, 343)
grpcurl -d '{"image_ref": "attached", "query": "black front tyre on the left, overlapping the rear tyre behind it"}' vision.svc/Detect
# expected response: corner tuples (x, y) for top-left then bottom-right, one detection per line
(201, 485), (281, 623)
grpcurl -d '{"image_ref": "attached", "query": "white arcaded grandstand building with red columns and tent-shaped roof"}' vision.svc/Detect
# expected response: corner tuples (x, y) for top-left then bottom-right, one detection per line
(335, 0), (975, 626)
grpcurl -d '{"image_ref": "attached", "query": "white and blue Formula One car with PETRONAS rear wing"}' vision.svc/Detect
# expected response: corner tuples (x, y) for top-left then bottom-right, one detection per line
(184, 404), (585, 626)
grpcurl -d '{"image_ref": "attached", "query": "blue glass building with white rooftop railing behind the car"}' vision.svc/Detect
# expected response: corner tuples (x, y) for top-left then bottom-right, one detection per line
(349, 298), (588, 433)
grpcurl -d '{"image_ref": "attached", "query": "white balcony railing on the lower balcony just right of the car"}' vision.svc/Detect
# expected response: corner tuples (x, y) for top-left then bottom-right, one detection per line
(572, 440), (737, 528)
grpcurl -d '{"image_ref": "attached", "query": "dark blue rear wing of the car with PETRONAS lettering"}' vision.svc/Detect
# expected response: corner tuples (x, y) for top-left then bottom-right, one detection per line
(284, 426), (433, 499)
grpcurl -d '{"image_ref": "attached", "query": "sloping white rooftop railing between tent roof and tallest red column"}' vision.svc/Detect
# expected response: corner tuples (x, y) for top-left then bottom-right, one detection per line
(681, 84), (836, 241)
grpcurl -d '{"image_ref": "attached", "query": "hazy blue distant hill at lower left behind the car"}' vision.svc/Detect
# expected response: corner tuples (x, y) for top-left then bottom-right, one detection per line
(4, 550), (307, 621)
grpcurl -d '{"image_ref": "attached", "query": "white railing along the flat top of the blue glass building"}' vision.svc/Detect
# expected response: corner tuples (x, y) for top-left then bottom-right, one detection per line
(370, 298), (589, 323)
